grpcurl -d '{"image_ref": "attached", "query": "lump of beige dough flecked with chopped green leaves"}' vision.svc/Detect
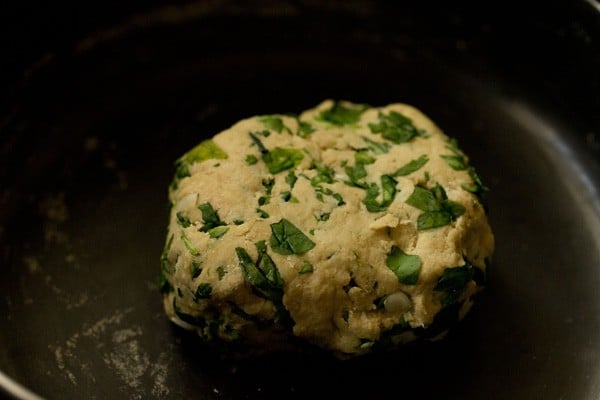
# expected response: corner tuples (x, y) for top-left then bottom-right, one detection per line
(159, 100), (494, 358)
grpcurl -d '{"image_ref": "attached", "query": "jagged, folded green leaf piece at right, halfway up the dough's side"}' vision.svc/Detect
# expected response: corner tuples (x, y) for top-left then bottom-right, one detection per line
(406, 183), (465, 230)
